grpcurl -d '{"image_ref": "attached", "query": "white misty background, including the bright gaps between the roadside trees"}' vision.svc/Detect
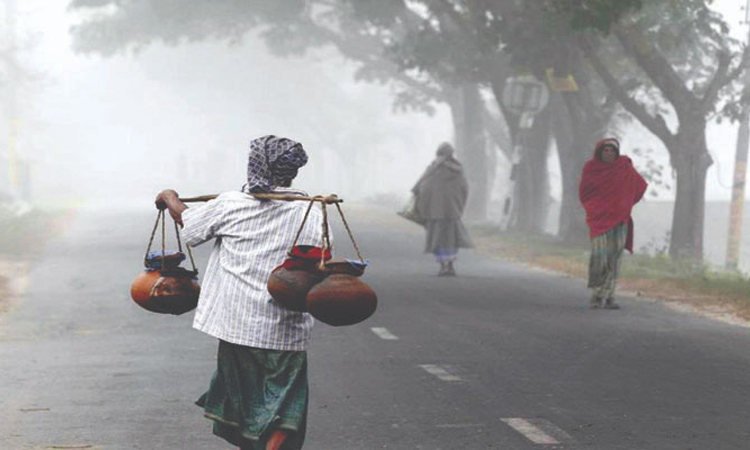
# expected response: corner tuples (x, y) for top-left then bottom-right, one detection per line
(0, 0), (750, 267)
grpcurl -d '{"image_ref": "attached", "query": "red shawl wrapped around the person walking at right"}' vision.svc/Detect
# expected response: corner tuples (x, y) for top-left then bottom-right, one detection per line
(578, 149), (648, 253)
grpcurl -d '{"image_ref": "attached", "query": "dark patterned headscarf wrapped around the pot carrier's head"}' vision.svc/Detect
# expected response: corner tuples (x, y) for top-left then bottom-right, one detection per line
(247, 135), (307, 193)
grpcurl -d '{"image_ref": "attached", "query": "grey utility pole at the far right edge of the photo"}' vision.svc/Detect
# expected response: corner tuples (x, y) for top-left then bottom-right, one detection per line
(726, 0), (750, 270)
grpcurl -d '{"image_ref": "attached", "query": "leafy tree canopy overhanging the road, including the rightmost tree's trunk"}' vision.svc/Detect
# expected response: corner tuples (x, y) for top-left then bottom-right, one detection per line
(71, 0), (750, 258)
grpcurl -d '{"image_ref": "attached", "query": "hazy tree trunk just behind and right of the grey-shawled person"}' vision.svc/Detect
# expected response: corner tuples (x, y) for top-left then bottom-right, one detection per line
(449, 84), (491, 222)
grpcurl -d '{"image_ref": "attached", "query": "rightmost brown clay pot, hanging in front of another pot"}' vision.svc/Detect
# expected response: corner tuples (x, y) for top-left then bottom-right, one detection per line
(307, 273), (378, 327)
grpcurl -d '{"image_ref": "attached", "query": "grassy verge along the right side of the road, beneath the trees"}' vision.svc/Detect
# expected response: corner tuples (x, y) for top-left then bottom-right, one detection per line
(471, 227), (750, 320)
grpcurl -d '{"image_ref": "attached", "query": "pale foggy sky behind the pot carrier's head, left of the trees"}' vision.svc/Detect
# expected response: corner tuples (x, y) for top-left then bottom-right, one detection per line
(14, 0), (452, 207)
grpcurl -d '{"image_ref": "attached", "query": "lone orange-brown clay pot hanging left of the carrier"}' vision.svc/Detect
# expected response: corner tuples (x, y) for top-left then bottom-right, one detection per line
(130, 269), (200, 315)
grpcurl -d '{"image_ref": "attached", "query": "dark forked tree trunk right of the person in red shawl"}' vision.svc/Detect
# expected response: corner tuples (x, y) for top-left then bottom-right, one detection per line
(669, 125), (712, 262)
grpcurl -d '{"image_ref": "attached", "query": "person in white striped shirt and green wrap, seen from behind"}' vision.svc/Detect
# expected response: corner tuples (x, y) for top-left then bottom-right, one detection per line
(156, 136), (322, 450)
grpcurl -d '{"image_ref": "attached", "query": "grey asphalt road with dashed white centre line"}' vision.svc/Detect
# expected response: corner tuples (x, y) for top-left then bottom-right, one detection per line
(0, 207), (750, 450)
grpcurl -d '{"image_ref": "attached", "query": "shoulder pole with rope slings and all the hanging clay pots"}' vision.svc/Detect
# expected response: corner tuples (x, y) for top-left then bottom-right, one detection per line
(131, 194), (377, 326)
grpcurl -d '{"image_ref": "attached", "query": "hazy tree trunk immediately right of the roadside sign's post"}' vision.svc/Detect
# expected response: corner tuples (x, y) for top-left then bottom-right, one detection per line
(513, 105), (552, 234)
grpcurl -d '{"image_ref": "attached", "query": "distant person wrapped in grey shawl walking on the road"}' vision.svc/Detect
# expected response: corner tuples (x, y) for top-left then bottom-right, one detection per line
(412, 142), (473, 276)
